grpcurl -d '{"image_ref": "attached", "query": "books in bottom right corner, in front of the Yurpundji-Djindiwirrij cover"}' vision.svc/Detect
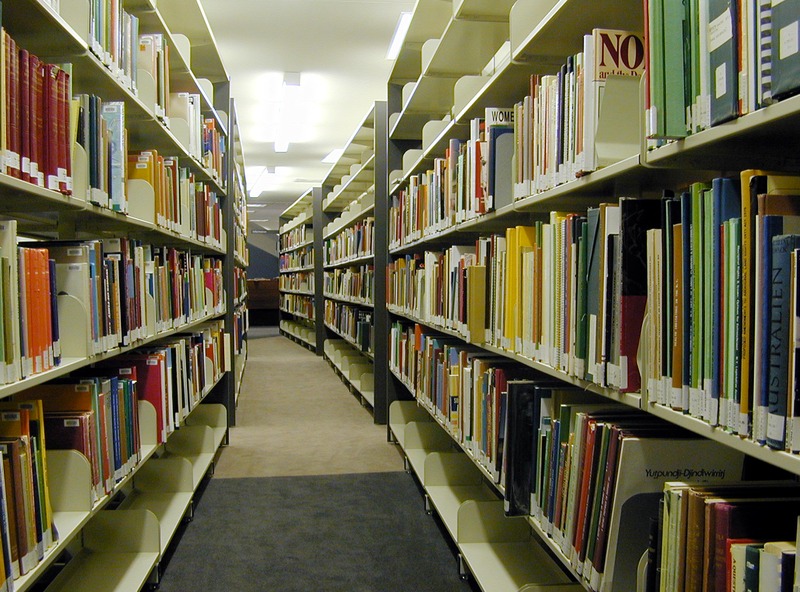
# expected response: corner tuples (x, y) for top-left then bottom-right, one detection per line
(646, 480), (800, 592)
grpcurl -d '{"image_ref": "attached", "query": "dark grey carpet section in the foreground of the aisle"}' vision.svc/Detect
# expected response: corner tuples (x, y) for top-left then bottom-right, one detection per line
(160, 472), (472, 592)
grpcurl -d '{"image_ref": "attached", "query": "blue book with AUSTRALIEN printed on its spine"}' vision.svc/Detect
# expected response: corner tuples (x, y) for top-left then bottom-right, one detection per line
(765, 234), (800, 450)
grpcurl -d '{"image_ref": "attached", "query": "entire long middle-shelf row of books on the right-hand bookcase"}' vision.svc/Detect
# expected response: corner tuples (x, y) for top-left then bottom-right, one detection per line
(387, 170), (800, 451)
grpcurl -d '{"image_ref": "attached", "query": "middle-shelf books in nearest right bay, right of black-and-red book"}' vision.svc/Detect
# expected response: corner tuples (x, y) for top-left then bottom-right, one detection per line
(639, 170), (800, 452)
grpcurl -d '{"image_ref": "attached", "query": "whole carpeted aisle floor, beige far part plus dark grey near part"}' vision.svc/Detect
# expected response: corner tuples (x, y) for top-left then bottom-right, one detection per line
(160, 328), (472, 592)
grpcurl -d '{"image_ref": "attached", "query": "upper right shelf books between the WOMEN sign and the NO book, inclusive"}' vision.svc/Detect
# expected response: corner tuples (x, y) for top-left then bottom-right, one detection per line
(512, 29), (645, 198)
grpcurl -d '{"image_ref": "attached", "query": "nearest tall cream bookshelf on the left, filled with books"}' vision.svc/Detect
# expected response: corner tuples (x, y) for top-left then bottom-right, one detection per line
(0, 0), (247, 591)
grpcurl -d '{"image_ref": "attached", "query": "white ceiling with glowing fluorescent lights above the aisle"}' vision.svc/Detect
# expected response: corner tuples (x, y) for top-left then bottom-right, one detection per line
(201, 0), (414, 230)
